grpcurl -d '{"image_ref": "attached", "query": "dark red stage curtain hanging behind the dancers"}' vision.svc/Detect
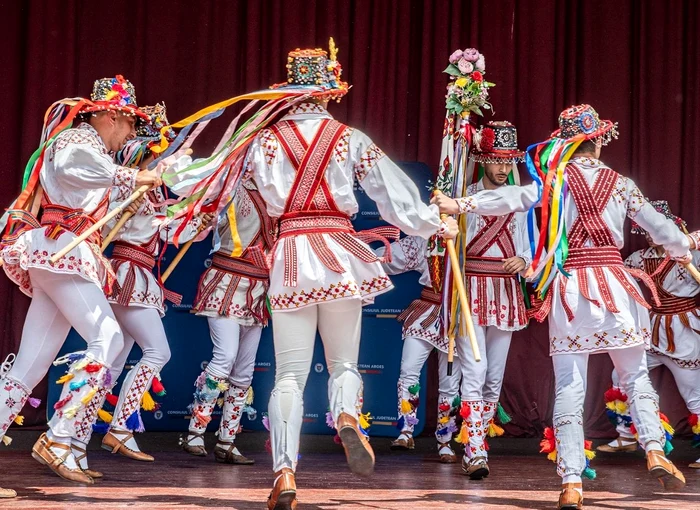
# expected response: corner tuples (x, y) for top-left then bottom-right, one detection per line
(0, 0), (700, 437)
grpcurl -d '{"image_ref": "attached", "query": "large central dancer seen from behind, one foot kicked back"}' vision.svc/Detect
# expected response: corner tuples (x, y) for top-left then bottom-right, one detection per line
(247, 41), (456, 509)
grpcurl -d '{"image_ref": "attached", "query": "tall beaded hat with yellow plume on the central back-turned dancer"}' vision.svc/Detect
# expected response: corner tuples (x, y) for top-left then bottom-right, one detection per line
(270, 37), (350, 101)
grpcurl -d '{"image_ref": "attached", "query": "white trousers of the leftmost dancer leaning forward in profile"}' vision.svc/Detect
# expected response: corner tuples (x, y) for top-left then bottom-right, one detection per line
(0, 269), (124, 438)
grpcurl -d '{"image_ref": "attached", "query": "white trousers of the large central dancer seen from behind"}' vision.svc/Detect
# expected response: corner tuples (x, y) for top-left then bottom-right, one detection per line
(268, 299), (362, 472)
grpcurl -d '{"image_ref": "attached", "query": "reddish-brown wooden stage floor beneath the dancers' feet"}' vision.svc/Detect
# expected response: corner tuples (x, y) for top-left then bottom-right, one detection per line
(0, 429), (700, 510)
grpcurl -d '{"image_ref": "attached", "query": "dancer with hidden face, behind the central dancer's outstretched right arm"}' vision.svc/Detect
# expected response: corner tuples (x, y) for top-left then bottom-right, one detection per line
(375, 236), (462, 464)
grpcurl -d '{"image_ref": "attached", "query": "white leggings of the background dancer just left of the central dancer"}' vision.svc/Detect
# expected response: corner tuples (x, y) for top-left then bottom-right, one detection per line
(206, 317), (262, 388)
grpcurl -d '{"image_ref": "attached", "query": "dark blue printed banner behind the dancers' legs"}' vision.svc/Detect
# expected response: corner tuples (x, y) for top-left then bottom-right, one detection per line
(47, 163), (432, 436)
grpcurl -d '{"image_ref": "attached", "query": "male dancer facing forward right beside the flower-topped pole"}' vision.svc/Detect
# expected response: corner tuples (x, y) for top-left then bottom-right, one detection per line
(456, 121), (532, 480)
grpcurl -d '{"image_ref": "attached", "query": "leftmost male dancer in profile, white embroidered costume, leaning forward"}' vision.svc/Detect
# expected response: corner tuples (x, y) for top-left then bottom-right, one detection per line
(0, 76), (160, 490)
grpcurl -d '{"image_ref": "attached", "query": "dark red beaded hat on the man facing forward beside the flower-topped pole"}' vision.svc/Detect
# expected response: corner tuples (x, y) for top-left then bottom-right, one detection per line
(472, 120), (525, 163)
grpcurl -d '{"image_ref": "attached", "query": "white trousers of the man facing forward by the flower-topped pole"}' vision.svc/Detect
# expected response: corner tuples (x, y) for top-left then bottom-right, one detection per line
(456, 324), (513, 402)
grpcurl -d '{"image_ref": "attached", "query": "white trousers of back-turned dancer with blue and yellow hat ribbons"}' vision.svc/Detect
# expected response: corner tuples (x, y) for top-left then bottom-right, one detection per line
(552, 345), (665, 483)
